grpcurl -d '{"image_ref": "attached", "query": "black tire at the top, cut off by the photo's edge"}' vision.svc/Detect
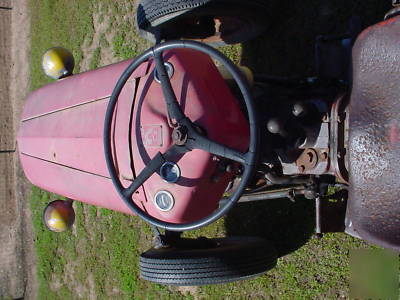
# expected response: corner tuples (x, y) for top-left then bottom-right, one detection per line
(137, 0), (269, 46)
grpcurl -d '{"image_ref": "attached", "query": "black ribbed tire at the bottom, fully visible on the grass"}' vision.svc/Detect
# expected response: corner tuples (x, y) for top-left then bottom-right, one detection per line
(140, 237), (277, 286)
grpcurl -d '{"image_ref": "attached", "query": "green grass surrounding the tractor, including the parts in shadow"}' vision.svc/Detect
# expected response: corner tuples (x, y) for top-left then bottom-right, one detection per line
(26, 0), (390, 299)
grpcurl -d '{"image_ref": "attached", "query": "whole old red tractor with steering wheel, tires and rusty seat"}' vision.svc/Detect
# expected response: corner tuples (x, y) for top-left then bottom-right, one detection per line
(18, 0), (400, 285)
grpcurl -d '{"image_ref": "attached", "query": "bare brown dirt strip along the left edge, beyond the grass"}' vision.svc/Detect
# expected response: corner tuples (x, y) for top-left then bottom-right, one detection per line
(0, 0), (37, 299)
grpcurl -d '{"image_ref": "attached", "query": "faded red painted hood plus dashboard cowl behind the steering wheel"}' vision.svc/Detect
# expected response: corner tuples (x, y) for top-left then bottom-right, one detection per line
(18, 50), (248, 223)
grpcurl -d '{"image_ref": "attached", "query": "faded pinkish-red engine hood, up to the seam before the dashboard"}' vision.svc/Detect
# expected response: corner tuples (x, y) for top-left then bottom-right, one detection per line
(18, 60), (148, 213)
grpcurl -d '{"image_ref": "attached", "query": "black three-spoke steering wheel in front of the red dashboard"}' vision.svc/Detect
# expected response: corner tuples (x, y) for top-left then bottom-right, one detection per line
(103, 41), (259, 231)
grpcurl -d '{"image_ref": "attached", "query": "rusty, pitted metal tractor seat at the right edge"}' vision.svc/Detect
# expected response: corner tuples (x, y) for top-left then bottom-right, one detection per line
(348, 17), (400, 251)
